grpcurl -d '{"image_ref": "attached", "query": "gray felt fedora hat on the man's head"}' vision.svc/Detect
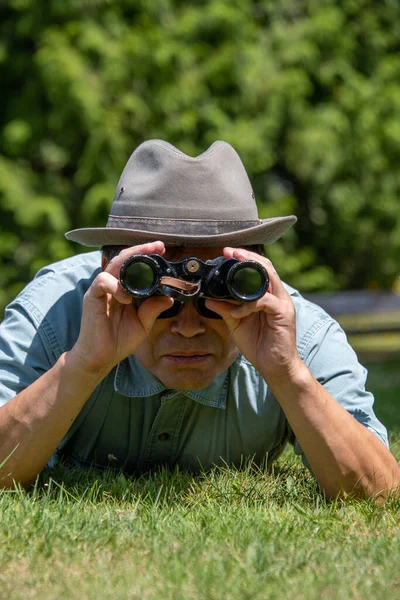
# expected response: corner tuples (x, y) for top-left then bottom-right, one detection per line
(65, 140), (296, 247)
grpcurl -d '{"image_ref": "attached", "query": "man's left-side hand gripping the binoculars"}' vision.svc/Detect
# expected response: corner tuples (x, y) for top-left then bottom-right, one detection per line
(69, 242), (173, 377)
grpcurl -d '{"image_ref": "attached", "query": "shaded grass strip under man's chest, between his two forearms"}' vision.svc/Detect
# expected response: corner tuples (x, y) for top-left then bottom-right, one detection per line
(16, 451), (326, 507)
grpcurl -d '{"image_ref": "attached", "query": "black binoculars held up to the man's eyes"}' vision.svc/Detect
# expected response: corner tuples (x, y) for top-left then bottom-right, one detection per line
(119, 254), (269, 319)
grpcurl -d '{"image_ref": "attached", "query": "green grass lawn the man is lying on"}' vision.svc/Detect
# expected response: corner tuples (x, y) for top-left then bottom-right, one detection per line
(0, 364), (400, 600)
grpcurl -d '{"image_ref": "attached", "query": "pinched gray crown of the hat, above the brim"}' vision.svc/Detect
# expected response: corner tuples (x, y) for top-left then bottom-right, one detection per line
(110, 140), (258, 221)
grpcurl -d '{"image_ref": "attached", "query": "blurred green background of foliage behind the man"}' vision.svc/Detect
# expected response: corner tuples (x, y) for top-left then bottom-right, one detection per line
(0, 0), (400, 357)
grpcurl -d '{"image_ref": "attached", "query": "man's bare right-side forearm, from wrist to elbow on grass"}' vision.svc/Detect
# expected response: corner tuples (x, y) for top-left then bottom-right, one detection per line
(270, 363), (400, 497)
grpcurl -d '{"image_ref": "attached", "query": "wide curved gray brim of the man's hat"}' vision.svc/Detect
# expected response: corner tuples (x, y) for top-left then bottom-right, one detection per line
(65, 215), (297, 248)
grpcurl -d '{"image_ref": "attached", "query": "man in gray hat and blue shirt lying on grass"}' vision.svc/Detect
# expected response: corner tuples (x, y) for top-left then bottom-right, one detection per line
(0, 140), (400, 497)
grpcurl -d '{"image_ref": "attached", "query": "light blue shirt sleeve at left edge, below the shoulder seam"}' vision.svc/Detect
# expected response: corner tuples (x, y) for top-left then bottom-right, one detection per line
(0, 301), (57, 406)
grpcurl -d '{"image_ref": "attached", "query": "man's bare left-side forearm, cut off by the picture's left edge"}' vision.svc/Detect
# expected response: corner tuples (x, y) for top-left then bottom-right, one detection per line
(0, 353), (104, 488)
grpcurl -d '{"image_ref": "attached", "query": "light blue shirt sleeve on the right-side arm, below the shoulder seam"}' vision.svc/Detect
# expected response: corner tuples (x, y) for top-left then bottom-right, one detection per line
(294, 318), (389, 467)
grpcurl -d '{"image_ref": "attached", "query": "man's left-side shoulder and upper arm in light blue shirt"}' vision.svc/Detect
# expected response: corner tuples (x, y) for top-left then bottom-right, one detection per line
(0, 252), (100, 405)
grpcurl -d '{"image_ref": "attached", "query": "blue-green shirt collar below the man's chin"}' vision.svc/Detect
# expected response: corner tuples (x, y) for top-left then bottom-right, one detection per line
(114, 356), (229, 409)
